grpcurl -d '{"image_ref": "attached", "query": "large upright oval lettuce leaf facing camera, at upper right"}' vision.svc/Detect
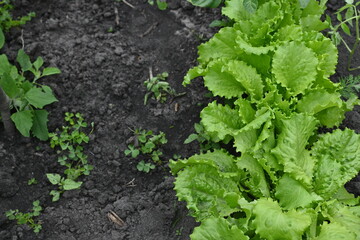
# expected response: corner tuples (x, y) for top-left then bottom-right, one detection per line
(272, 42), (318, 96)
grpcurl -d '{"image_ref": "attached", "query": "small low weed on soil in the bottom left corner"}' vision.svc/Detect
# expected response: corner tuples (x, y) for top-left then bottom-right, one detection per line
(5, 200), (42, 233)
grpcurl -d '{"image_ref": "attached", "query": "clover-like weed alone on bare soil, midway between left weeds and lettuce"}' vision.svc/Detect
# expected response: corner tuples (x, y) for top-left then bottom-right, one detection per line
(124, 128), (167, 172)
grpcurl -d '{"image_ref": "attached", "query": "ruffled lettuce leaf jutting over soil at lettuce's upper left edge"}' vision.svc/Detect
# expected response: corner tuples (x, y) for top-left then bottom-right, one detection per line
(198, 27), (242, 64)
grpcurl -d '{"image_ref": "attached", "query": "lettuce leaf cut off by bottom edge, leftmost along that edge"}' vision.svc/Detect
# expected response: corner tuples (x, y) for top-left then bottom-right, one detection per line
(190, 217), (249, 240)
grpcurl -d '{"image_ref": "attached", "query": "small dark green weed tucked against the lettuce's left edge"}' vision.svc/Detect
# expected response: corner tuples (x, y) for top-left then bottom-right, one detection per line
(184, 123), (220, 152)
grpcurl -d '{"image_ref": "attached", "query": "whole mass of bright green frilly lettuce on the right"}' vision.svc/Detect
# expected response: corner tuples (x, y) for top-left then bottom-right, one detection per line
(170, 0), (360, 240)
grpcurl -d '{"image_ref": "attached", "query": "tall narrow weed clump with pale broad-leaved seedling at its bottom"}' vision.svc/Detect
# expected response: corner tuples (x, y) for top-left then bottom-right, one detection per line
(47, 112), (94, 201)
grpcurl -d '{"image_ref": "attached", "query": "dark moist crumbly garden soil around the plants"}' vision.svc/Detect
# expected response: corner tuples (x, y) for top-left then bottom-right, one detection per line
(0, 0), (360, 240)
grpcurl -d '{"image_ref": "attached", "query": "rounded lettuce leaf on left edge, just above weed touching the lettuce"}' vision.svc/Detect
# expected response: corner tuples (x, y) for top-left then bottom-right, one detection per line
(200, 101), (243, 141)
